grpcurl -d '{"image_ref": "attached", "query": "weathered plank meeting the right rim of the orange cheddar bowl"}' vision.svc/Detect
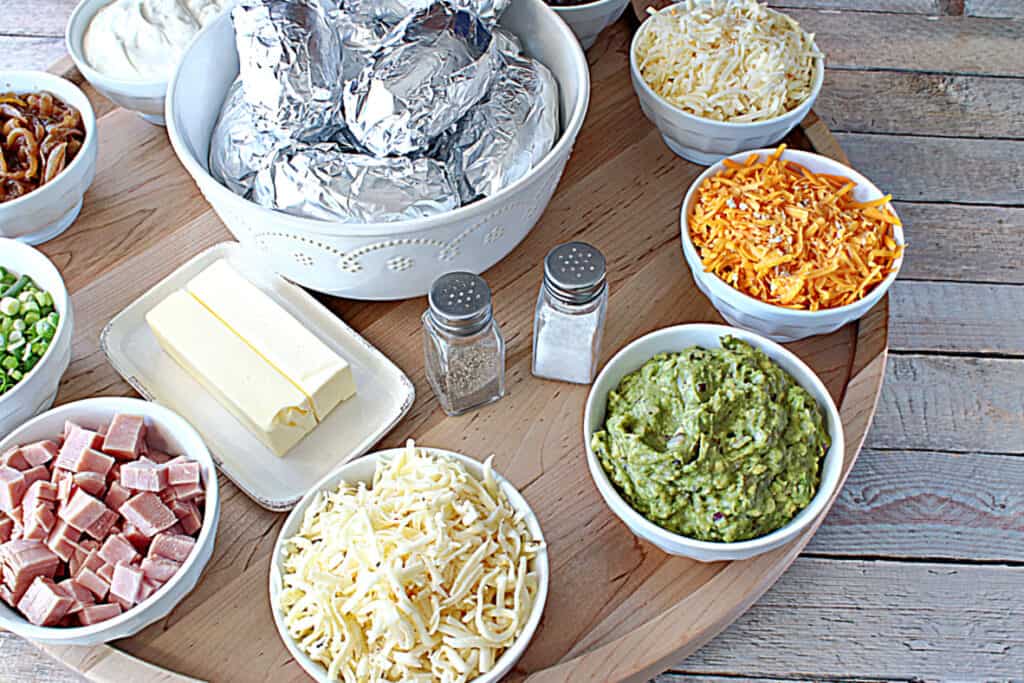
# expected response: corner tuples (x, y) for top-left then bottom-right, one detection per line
(897, 204), (1024, 285)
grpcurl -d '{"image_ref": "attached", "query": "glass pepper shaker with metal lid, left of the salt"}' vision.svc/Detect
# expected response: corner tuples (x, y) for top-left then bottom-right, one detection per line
(423, 272), (505, 416)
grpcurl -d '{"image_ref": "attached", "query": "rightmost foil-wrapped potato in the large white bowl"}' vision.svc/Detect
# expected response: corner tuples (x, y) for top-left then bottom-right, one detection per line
(446, 52), (559, 204)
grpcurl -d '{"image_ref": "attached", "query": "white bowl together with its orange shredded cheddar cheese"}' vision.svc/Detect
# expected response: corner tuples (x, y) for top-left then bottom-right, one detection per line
(680, 145), (904, 342)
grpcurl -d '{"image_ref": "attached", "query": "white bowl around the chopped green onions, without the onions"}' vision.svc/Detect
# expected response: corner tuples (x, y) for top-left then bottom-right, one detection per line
(0, 237), (75, 437)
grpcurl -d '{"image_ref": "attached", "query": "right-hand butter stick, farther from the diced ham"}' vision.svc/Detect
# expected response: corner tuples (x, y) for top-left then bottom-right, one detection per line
(185, 259), (355, 422)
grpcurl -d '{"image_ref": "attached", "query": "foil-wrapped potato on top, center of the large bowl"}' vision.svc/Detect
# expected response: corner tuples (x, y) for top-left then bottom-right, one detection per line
(344, 2), (501, 157)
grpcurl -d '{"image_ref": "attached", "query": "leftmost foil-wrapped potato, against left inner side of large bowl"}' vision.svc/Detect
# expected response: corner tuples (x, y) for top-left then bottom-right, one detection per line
(210, 79), (285, 197)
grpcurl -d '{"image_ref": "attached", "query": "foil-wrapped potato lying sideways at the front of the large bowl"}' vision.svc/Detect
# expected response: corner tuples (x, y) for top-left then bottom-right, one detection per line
(251, 142), (459, 223)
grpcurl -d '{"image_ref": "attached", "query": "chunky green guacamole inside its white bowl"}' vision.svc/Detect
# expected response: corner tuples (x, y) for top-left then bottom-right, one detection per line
(591, 337), (831, 542)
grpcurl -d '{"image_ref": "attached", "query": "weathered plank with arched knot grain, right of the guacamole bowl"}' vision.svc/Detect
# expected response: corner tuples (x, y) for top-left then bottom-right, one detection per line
(807, 449), (1024, 563)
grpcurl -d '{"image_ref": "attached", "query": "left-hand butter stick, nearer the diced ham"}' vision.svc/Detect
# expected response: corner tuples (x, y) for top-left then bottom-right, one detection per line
(145, 290), (316, 456)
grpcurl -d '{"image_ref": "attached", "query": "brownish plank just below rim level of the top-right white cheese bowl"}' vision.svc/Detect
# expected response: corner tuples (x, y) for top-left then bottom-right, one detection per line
(814, 70), (1024, 138)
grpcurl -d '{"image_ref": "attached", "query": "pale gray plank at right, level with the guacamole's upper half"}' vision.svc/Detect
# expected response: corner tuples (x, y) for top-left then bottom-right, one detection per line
(867, 354), (1024, 454)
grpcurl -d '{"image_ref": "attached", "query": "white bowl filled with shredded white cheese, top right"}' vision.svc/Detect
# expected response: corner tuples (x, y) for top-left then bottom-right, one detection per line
(630, 0), (824, 165)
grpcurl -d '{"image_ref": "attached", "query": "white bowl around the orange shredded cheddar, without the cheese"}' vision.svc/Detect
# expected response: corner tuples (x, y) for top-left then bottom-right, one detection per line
(679, 150), (903, 342)
